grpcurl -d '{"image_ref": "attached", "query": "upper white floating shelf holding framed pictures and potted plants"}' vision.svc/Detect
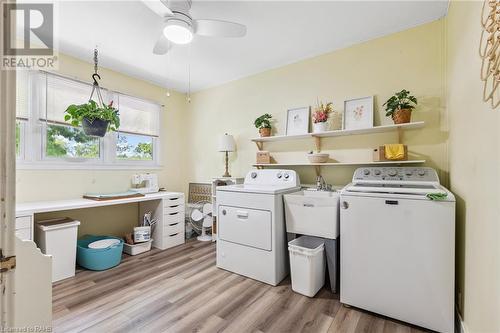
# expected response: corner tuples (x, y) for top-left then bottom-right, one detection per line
(252, 121), (425, 142)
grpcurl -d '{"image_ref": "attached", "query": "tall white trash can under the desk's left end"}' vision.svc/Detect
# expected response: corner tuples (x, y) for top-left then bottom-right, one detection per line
(35, 218), (80, 282)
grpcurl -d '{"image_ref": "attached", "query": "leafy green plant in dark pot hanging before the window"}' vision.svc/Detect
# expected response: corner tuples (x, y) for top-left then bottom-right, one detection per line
(64, 100), (120, 137)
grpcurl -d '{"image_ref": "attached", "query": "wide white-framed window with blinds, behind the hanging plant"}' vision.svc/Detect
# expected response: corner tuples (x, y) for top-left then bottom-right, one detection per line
(16, 71), (161, 168)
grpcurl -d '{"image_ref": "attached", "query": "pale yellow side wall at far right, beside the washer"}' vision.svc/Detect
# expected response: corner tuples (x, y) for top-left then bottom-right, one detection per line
(446, 1), (500, 333)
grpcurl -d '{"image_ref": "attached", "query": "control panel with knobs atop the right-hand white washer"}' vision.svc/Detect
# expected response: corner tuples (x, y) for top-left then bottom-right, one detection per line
(352, 167), (439, 183)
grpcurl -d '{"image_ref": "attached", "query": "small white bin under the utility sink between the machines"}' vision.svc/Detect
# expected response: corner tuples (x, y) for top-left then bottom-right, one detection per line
(288, 236), (326, 297)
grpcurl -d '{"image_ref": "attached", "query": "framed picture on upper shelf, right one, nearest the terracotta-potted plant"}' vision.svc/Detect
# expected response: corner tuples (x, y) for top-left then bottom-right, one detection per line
(344, 96), (373, 130)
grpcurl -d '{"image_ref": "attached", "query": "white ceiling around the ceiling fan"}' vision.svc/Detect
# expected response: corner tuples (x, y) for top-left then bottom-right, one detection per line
(52, 1), (448, 92)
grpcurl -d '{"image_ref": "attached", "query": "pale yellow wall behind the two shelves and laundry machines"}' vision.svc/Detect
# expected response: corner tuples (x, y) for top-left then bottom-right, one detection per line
(187, 20), (448, 185)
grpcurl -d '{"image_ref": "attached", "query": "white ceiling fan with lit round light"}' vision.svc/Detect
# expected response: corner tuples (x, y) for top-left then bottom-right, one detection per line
(143, 0), (247, 55)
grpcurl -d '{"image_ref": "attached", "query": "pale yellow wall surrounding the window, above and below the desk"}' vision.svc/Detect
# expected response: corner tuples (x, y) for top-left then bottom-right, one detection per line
(16, 54), (187, 235)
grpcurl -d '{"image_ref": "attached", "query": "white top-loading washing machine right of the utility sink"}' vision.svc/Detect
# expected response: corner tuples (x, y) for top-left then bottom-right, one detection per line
(340, 167), (455, 332)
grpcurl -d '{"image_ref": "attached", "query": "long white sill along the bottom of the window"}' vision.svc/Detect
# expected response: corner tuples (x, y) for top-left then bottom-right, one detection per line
(16, 162), (163, 170)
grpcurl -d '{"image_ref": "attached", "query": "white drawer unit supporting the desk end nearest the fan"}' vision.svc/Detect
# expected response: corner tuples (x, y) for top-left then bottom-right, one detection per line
(146, 193), (185, 250)
